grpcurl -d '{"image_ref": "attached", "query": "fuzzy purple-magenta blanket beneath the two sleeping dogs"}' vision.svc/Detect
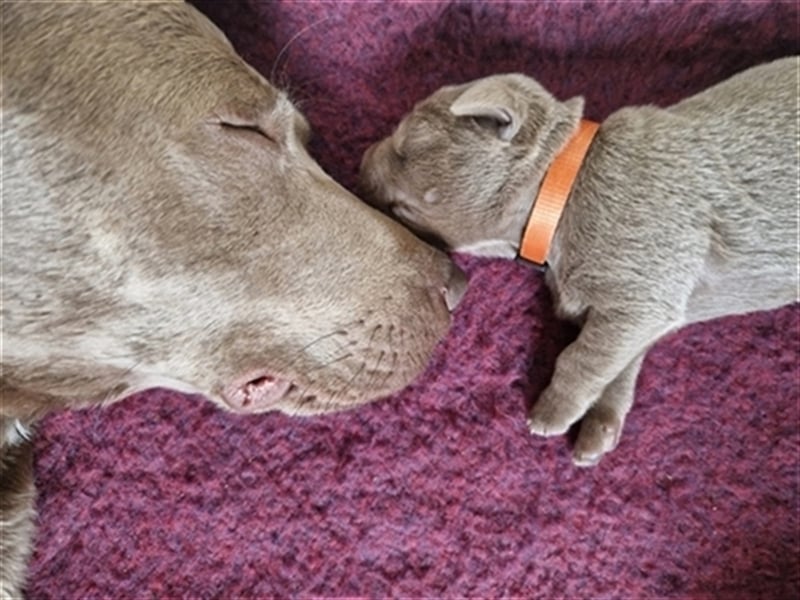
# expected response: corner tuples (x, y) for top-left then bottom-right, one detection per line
(29, 0), (800, 599)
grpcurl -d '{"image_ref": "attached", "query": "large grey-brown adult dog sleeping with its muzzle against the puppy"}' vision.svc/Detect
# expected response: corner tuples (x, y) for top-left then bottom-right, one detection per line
(0, 2), (464, 597)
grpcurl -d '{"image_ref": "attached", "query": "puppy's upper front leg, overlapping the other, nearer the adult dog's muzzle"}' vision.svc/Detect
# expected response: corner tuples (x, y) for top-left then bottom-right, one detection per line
(528, 309), (679, 436)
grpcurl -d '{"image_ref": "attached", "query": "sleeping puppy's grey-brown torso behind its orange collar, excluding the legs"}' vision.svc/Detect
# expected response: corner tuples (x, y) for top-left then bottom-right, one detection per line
(556, 57), (800, 321)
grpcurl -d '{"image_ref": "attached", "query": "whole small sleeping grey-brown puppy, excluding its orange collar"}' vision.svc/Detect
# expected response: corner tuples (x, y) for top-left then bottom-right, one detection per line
(362, 58), (798, 464)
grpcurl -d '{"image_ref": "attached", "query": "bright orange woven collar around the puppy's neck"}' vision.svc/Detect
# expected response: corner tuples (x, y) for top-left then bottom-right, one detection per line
(519, 119), (600, 266)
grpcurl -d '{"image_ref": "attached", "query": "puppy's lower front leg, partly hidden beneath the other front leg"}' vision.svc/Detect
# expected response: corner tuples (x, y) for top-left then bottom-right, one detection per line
(572, 353), (645, 467)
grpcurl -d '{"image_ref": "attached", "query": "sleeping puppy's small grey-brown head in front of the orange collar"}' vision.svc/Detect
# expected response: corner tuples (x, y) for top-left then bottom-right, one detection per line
(361, 74), (583, 257)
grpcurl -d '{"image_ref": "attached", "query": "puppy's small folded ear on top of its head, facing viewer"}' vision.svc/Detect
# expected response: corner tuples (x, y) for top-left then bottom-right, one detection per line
(450, 77), (525, 142)
